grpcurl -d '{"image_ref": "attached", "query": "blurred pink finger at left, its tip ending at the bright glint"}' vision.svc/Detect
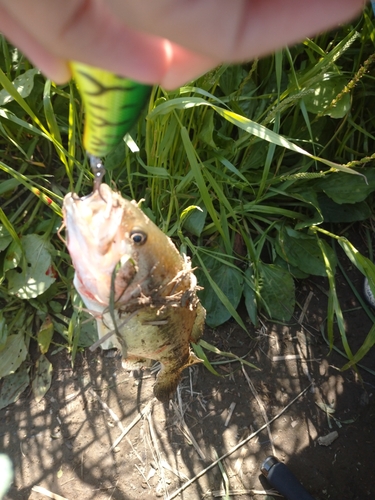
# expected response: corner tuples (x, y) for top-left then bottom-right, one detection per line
(0, 0), (170, 83)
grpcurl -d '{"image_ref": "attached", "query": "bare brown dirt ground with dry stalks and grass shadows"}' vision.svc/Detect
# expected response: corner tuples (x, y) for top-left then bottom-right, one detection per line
(0, 254), (375, 500)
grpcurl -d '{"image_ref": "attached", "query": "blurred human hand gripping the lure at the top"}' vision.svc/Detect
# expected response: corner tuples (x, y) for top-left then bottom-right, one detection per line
(0, 0), (365, 89)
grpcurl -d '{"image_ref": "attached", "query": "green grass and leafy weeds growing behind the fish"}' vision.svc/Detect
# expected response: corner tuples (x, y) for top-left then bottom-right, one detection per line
(0, 9), (375, 402)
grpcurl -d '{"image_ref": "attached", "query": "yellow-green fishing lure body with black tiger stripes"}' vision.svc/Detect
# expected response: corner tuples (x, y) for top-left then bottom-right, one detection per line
(70, 62), (151, 158)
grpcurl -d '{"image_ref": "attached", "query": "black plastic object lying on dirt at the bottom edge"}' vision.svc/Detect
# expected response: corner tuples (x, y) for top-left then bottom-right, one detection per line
(260, 455), (314, 500)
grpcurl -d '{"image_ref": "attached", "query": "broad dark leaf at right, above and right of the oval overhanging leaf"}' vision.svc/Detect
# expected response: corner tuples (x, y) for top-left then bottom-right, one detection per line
(275, 226), (336, 276)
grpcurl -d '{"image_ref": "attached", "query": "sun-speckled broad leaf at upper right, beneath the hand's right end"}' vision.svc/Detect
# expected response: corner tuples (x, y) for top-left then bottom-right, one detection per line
(303, 73), (350, 118)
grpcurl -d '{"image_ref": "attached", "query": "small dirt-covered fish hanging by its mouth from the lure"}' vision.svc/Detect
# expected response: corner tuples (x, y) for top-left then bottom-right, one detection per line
(63, 183), (205, 402)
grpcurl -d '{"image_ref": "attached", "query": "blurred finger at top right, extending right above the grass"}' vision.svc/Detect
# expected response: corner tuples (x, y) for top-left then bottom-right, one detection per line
(107, 0), (365, 62)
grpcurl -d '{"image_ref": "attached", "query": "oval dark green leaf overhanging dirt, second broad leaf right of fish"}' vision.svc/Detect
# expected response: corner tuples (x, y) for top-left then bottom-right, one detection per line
(258, 262), (295, 321)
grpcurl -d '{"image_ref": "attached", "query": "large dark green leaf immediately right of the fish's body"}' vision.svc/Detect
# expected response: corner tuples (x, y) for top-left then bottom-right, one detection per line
(197, 255), (243, 328)
